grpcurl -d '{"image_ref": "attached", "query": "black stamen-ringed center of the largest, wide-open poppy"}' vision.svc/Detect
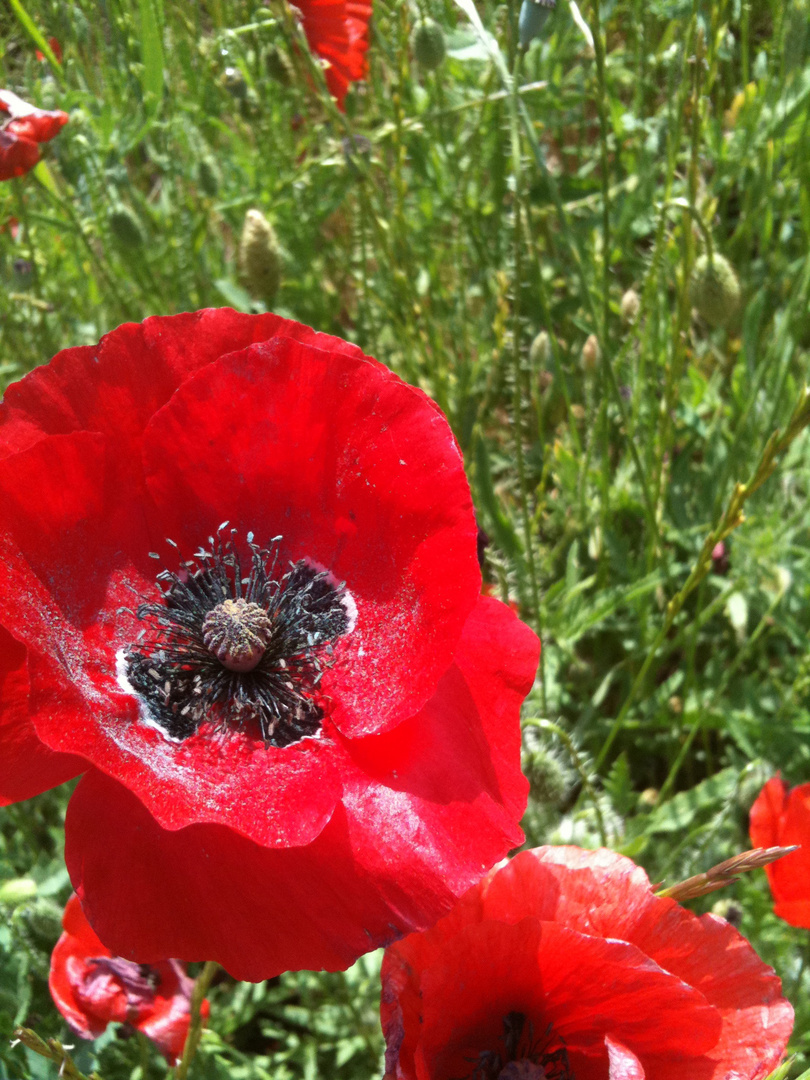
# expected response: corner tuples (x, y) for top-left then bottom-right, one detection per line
(119, 523), (356, 746)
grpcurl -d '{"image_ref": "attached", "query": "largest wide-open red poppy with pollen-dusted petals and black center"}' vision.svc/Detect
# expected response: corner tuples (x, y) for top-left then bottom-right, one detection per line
(0, 310), (539, 980)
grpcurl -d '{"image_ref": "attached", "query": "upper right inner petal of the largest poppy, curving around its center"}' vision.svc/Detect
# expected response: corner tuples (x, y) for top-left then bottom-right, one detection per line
(144, 339), (481, 735)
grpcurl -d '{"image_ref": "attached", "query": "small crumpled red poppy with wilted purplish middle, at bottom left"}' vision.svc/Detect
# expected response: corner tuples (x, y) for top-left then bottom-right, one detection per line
(49, 894), (210, 1065)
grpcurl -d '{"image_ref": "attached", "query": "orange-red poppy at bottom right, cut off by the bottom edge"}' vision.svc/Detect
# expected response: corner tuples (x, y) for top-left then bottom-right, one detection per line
(381, 848), (793, 1080)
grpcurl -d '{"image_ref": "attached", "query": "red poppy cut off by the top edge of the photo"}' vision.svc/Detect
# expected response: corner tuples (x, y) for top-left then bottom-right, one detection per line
(295, 0), (372, 109)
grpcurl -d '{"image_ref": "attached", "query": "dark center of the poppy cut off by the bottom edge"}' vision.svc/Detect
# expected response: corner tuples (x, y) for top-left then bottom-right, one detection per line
(471, 1012), (575, 1080)
